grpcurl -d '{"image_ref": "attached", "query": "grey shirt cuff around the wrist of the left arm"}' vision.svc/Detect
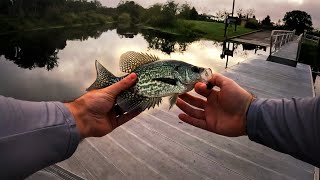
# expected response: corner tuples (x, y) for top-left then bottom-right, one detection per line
(53, 102), (80, 159)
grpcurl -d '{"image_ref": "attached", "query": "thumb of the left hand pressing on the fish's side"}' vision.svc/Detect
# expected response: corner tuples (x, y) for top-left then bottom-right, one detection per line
(104, 73), (137, 96)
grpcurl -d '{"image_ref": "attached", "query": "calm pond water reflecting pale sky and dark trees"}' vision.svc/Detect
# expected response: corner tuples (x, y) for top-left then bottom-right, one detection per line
(0, 25), (267, 101)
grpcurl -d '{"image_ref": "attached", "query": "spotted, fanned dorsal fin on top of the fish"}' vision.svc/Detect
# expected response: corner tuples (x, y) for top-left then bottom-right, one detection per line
(119, 51), (159, 73)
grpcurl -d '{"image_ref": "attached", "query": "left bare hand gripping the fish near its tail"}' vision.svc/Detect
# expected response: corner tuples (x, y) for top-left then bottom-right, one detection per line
(65, 73), (141, 138)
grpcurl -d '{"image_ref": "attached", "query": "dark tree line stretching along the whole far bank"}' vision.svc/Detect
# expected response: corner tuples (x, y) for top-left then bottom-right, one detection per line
(0, 0), (312, 33)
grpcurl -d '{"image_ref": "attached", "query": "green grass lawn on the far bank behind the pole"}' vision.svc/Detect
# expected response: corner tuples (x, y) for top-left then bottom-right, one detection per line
(183, 20), (255, 41)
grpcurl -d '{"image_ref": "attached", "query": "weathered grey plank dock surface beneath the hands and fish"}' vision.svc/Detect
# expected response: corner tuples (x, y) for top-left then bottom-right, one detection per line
(27, 53), (314, 180)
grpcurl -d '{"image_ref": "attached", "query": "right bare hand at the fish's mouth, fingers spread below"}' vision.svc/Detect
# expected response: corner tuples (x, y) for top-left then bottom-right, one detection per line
(177, 74), (253, 136)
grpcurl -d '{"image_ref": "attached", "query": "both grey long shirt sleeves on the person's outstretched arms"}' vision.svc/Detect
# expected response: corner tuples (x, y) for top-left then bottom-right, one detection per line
(0, 96), (320, 179)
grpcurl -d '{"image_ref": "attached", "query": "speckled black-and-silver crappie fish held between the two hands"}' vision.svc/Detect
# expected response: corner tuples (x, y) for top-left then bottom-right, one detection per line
(87, 51), (212, 114)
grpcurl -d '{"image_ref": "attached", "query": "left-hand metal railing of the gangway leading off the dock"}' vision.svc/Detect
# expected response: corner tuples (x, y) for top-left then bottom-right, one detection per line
(270, 30), (296, 55)
